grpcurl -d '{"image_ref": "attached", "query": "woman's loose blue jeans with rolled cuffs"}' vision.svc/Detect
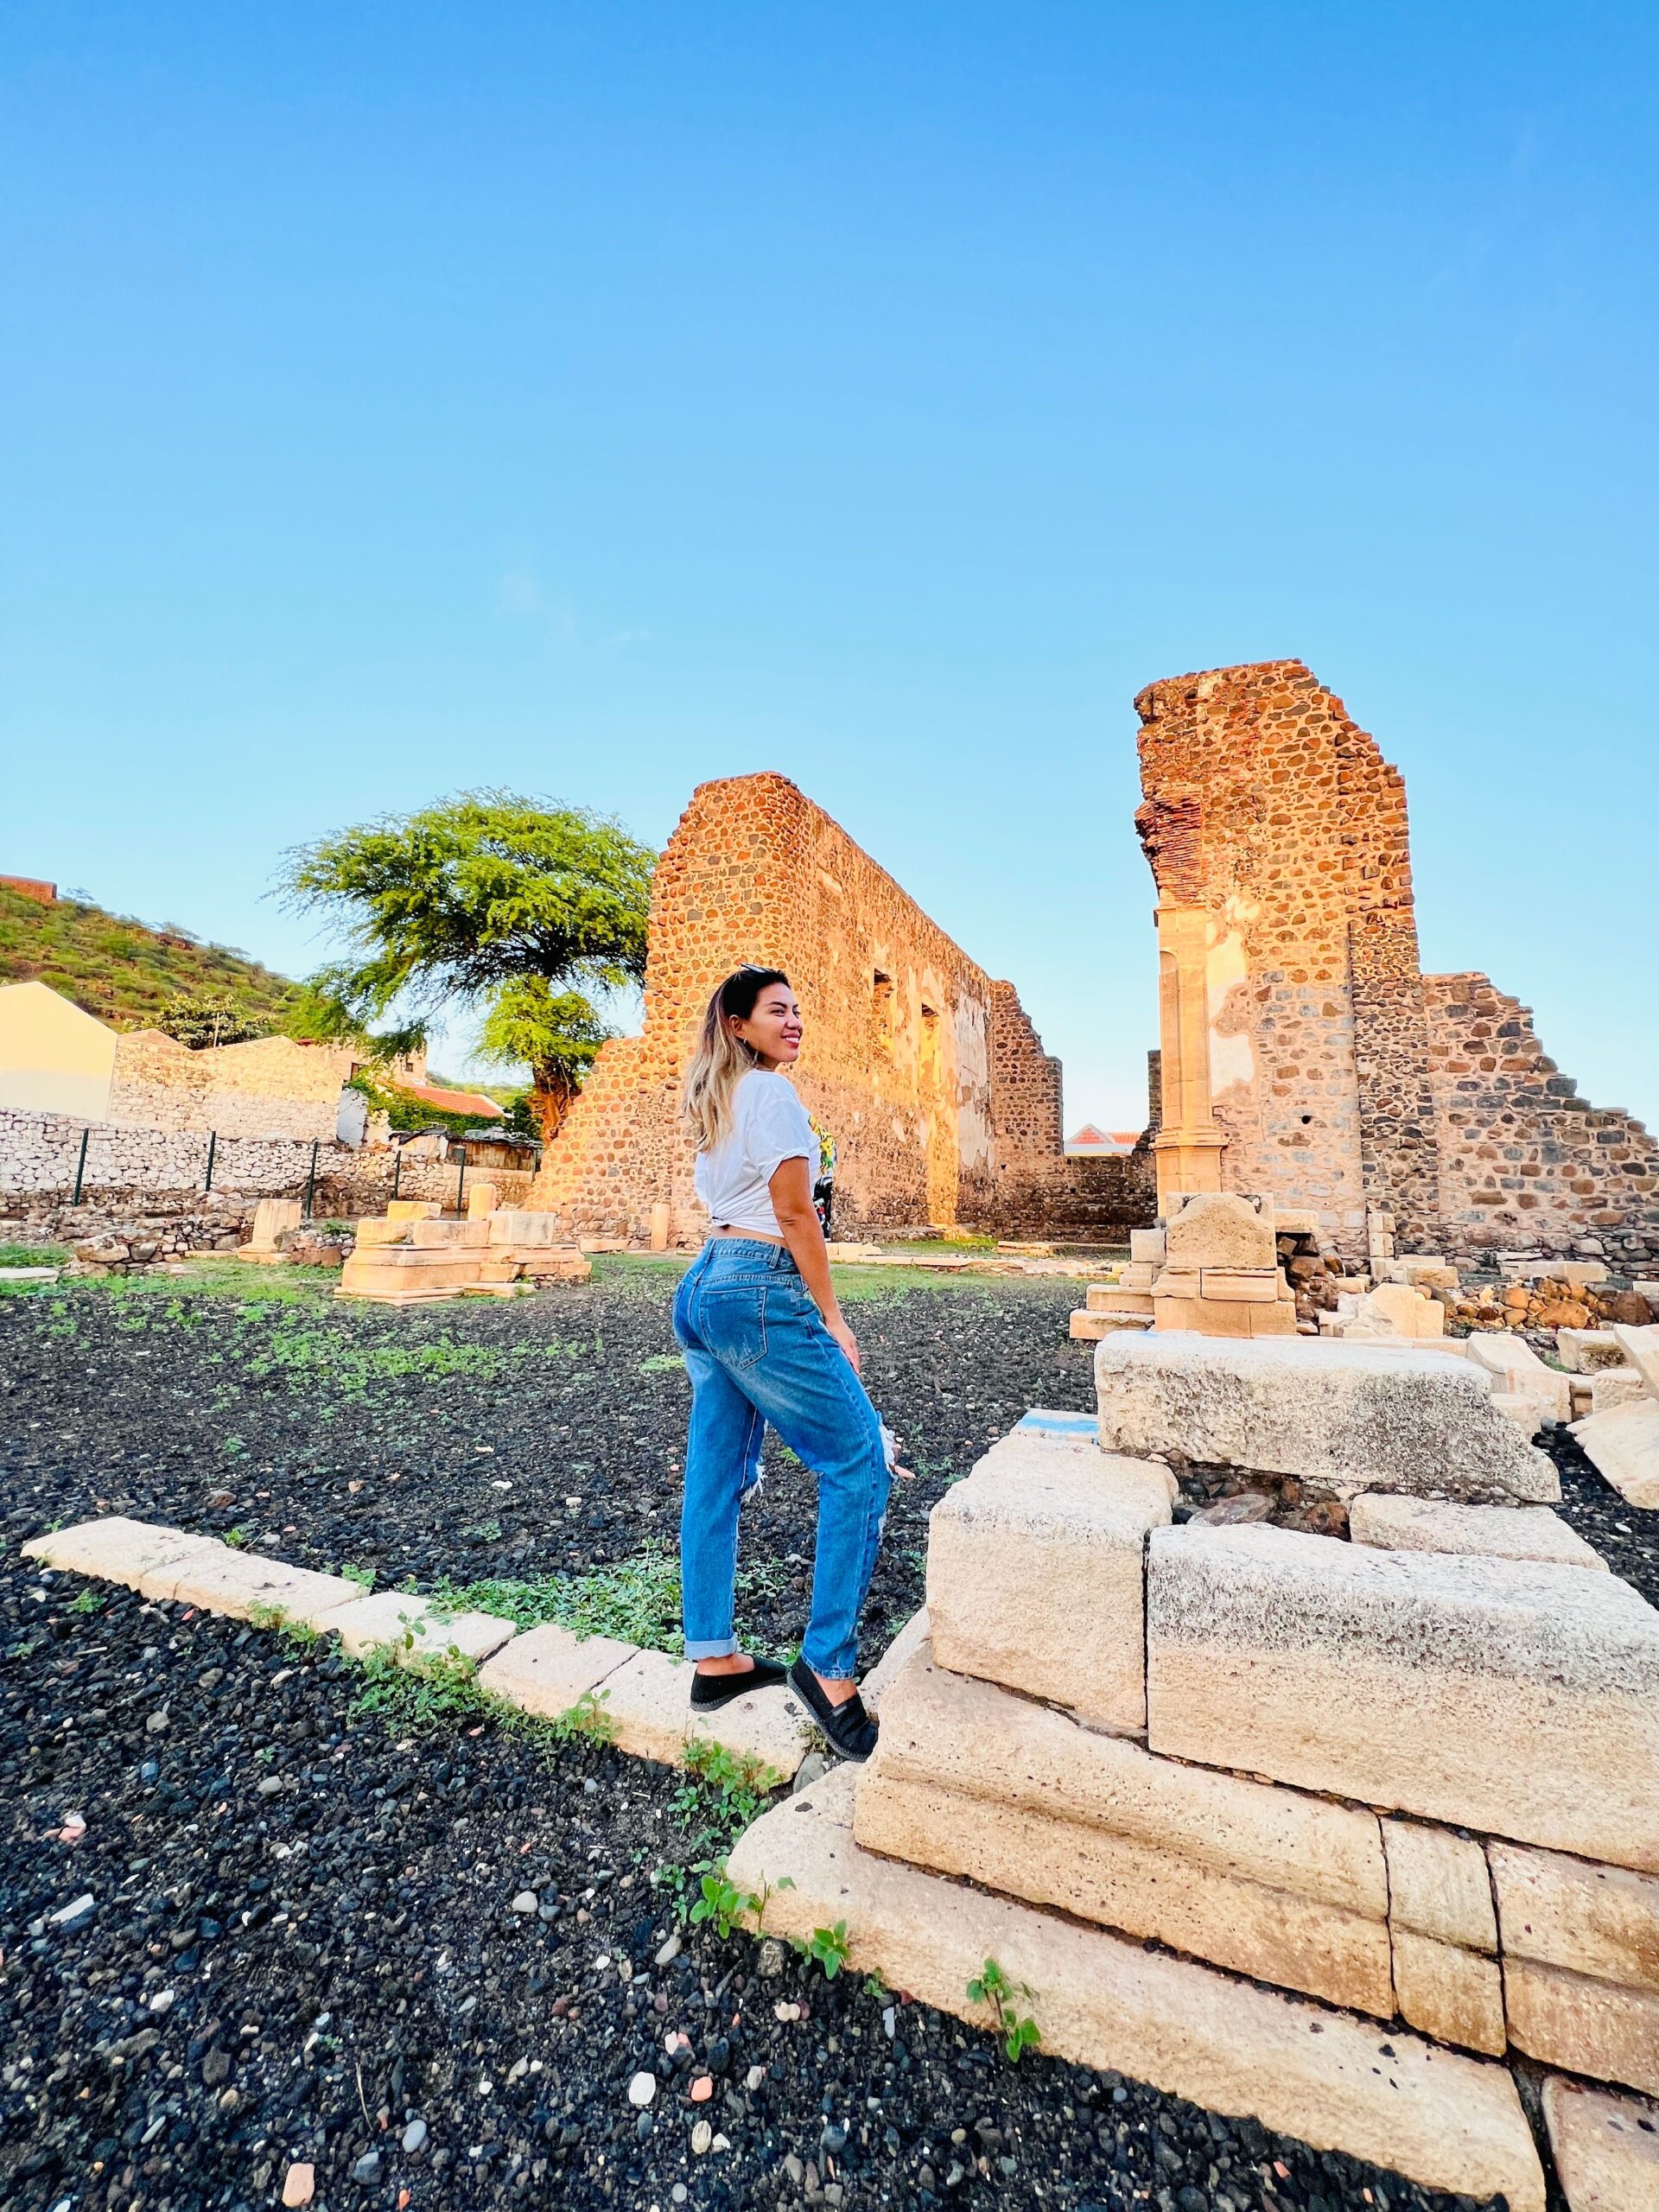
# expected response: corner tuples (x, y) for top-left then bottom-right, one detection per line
(675, 1236), (892, 1681)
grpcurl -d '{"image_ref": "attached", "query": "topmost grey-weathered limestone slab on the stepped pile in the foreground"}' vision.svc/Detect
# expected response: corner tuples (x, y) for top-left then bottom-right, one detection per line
(1095, 1330), (1561, 1504)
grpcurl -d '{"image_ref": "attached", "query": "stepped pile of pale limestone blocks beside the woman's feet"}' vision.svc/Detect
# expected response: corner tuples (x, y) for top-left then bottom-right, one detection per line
(730, 1332), (1659, 2212)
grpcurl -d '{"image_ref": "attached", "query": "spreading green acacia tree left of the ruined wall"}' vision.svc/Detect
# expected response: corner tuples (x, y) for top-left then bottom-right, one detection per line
(279, 790), (655, 1137)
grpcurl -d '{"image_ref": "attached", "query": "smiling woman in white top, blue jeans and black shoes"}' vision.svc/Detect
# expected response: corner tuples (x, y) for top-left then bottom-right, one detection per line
(675, 967), (889, 1758)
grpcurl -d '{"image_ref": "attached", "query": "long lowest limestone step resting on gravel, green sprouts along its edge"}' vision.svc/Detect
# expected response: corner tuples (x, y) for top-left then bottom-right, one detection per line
(728, 1767), (1544, 2212)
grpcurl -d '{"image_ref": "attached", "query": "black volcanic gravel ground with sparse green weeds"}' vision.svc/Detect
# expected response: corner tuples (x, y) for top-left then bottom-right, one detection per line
(0, 1265), (1652, 2212)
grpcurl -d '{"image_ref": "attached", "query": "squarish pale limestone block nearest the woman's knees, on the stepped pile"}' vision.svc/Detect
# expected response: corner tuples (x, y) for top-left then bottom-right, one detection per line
(927, 1438), (1170, 1730)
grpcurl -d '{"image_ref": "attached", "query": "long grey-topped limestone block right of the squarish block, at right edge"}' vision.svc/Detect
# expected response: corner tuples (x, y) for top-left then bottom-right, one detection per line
(1146, 1526), (1659, 1872)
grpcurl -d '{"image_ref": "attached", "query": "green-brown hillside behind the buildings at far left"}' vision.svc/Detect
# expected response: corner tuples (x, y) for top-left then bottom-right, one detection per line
(0, 885), (301, 1031)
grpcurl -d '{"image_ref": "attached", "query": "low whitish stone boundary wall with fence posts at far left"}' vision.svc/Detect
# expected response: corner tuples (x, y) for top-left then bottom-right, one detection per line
(0, 1113), (533, 1217)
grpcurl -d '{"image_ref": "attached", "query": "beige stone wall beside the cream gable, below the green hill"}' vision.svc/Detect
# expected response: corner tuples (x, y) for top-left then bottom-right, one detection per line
(108, 1028), (354, 1144)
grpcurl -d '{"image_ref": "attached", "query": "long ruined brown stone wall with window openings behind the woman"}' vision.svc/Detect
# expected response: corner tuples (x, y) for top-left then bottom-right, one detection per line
(536, 774), (1066, 1239)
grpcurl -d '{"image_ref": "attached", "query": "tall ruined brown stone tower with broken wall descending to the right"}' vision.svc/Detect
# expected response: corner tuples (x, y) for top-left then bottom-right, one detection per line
(1135, 661), (1659, 1263)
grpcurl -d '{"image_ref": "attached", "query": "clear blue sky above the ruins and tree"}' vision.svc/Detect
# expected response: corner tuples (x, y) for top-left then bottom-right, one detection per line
(0, 0), (1659, 1123)
